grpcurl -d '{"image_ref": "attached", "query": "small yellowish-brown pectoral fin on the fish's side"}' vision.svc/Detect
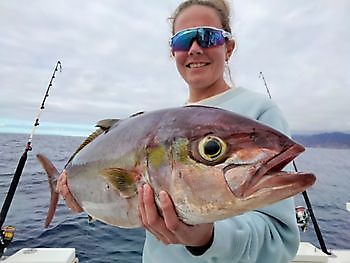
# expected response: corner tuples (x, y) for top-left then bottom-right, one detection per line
(101, 168), (138, 198)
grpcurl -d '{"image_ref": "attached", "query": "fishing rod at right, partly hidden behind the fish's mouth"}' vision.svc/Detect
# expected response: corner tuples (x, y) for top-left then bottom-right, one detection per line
(259, 71), (332, 255)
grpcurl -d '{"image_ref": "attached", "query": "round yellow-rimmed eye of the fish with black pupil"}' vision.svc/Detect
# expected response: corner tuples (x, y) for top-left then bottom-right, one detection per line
(198, 135), (226, 161)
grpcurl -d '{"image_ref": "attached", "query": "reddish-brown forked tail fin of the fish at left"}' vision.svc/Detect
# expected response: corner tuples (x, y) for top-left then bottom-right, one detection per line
(36, 154), (59, 228)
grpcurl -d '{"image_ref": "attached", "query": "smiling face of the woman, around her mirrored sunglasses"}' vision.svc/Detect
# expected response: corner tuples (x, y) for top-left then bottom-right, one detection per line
(174, 5), (234, 99)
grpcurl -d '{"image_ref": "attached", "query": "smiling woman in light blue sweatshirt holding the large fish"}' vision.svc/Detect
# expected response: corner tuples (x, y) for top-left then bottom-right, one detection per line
(58, 0), (299, 263)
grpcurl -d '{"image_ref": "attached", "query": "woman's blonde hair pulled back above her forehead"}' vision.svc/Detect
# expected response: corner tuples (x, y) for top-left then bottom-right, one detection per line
(169, 0), (232, 34)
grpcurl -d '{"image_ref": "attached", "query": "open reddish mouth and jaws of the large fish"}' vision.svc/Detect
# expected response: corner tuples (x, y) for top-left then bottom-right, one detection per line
(223, 144), (315, 199)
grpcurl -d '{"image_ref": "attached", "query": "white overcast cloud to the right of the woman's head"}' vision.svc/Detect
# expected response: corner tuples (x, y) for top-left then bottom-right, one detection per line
(234, 1), (350, 131)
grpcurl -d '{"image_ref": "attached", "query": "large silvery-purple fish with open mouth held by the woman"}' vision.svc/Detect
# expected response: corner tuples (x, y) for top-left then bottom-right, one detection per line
(38, 106), (315, 228)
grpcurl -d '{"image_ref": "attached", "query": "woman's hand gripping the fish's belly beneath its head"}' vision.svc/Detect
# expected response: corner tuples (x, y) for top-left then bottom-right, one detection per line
(139, 184), (214, 247)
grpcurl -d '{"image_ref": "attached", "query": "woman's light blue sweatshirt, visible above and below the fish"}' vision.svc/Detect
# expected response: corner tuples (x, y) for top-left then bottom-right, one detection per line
(143, 88), (299, 263)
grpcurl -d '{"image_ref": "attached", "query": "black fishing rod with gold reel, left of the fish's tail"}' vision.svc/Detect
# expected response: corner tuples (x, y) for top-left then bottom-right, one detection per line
(0, 61), (62, 258)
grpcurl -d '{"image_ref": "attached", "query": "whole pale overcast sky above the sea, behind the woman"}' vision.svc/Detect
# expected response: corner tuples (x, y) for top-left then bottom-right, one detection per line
(0, 0), (350, 135)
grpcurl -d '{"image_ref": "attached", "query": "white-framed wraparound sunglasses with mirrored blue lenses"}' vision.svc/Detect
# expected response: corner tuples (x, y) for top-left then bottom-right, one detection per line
(169, 27), (232, 52)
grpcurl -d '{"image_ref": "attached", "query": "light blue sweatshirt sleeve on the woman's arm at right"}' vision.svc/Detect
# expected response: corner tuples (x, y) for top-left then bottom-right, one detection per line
(186, 102), (300, 263)
